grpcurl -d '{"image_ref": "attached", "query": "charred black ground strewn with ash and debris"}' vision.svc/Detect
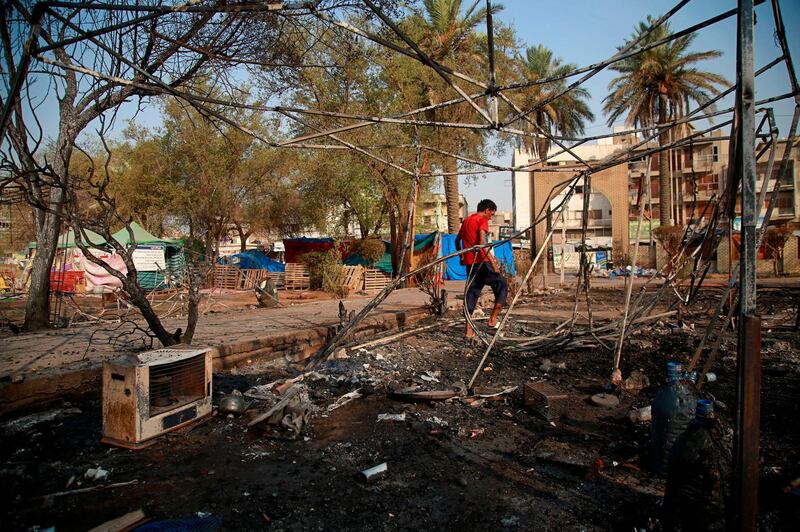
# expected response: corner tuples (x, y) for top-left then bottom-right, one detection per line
(0, 289), (800, 531)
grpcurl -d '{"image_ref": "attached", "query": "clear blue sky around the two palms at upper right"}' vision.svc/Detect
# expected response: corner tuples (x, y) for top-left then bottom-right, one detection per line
(460, 0), (800, 211)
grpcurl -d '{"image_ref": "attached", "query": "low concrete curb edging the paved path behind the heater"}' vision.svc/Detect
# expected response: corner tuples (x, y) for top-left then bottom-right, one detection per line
(0, 307), (430, 418)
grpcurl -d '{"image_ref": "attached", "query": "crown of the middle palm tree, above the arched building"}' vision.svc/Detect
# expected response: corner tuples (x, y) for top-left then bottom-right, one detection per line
(516, 44), (594, 158)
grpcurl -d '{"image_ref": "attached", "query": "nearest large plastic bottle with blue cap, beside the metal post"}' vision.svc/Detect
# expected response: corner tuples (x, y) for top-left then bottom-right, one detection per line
(663, 399), (731, 532)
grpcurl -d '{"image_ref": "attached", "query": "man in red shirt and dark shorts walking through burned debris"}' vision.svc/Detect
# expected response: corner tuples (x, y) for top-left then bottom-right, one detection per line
(456, 199), (508, 338)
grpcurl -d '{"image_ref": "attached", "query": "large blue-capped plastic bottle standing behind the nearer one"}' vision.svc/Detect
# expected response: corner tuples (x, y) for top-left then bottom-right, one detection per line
(650, 362), (695, 475)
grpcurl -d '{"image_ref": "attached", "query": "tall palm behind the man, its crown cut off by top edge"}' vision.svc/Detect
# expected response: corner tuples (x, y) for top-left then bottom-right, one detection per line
(420, 0), (502, 233)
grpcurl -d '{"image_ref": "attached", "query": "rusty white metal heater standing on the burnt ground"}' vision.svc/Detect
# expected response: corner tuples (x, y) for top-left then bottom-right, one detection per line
(101, 347), (211, 449)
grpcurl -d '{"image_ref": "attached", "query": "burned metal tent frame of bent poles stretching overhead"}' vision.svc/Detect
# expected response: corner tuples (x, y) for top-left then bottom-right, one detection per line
(0, 0), (800, 523)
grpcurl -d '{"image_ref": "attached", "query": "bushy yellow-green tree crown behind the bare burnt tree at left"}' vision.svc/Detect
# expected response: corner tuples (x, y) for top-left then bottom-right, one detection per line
(116, 99), (303, 257)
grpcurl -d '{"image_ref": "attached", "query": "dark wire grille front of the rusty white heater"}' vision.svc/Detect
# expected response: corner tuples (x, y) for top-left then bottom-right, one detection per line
(148, 354), (206, 417)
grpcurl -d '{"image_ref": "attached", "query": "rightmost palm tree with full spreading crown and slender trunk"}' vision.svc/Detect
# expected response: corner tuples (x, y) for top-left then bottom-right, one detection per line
(603, 16), (728, 227)
